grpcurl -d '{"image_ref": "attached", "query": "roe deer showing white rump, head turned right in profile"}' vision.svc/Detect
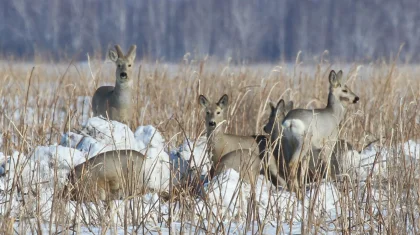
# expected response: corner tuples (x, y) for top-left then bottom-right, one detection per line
(282, 70), (359, 196)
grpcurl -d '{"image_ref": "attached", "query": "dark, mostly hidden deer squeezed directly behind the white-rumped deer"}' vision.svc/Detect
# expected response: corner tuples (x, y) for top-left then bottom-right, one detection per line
(264, 99), (293, 187)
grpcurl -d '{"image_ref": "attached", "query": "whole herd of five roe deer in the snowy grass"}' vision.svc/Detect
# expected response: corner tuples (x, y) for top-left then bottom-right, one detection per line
(65, 45), (359, 207)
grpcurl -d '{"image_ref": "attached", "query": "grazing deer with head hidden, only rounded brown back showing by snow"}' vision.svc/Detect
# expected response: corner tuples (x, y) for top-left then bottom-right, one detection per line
(64, 150), (145, 207)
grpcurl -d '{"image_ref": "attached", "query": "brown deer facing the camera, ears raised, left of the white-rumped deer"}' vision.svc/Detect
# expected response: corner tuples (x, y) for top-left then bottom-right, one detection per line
(199, 95), (284, 185)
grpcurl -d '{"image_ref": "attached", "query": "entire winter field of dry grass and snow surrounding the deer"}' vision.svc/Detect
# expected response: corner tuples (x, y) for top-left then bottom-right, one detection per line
(0, 57), (420, 234)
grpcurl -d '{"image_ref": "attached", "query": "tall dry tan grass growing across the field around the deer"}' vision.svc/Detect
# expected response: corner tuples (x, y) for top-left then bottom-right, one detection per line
(0, 53), (420, 234)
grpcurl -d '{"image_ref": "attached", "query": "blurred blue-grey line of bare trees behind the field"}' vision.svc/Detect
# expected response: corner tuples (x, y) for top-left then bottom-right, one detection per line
(0, 0), (420, 61)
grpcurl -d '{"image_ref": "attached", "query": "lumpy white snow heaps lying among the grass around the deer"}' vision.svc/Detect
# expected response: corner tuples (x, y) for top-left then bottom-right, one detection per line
(0, 117), (420, 234)
